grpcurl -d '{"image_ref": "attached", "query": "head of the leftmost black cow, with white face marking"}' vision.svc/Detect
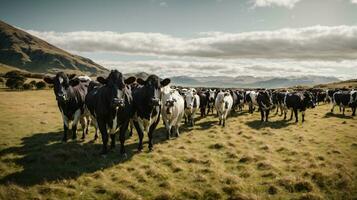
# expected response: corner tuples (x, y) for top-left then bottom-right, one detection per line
(43, 72), (76, 102)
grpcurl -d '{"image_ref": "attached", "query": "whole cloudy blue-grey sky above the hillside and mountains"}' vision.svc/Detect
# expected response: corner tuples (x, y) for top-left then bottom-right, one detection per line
(0, 0), (357, 79)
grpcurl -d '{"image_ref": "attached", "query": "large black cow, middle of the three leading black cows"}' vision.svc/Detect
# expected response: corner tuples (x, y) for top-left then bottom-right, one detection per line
(85, 70), (136, 156)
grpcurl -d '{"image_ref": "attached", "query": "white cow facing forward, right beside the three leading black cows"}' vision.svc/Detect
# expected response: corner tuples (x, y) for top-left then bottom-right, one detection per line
(161, 86), (185, 139)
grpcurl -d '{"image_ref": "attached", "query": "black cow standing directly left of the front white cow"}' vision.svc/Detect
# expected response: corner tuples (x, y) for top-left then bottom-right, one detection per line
(133, 75), (170, 151)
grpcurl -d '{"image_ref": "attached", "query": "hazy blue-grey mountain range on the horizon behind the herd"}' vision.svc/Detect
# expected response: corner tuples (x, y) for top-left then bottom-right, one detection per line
(125, 72), (340, 88)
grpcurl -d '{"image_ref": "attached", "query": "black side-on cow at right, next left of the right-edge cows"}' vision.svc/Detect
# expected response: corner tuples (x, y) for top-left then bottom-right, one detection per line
(284, 91), (315, 122)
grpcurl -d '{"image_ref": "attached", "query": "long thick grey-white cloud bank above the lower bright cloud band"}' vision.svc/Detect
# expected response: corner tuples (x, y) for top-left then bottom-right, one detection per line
(28, 26), (357, 60)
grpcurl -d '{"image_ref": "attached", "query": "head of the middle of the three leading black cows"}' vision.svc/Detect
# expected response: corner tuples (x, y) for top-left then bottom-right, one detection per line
(97, 70), (136, 108)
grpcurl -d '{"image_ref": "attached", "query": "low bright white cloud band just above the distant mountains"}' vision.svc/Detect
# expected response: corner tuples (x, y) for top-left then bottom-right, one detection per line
(98, 59), (357, 79)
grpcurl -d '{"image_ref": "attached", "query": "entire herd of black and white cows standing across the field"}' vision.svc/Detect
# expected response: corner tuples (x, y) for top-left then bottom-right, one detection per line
(44, 70), (357, 155)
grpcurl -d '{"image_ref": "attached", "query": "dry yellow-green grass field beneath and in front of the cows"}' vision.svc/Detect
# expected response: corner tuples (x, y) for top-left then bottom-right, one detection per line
(0, 90), (357, 200)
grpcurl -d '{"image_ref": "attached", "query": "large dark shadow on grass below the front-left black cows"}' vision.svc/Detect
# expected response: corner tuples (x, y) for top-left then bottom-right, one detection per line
(0, 128), (170, 186)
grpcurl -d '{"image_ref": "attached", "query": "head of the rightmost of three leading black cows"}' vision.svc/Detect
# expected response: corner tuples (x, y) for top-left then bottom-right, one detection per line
(137, 75), (171, 106)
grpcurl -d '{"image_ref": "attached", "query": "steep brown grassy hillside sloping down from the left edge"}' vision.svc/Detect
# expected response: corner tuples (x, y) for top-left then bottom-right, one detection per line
(0, 21), (108, 74)
